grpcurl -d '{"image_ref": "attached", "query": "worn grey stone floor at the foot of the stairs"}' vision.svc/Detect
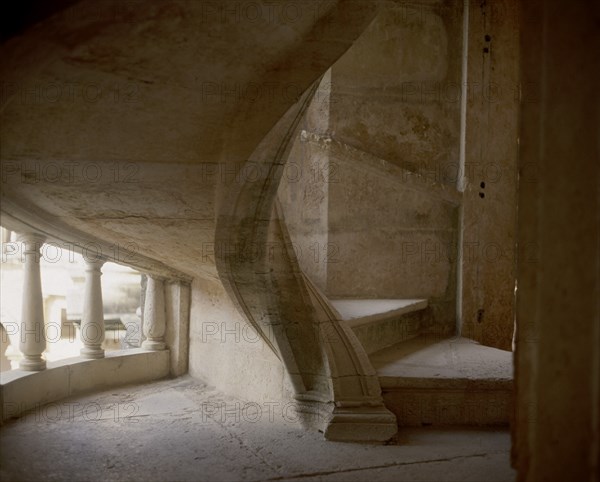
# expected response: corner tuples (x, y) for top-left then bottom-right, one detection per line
(0, 377), (515, 482)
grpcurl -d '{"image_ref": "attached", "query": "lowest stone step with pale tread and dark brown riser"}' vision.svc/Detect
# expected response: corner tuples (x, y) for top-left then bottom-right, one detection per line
(370, 336), (513, 426)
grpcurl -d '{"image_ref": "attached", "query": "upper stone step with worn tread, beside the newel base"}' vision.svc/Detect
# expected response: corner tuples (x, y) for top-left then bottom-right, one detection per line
(331, 299), (428, 354)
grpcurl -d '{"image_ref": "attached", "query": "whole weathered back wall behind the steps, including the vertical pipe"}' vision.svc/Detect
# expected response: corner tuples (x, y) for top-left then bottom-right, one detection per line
(280, 1), (519, 349)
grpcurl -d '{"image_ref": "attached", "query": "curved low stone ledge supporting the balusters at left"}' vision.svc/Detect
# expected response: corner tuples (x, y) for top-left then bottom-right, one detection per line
(0, 349), (169, 422)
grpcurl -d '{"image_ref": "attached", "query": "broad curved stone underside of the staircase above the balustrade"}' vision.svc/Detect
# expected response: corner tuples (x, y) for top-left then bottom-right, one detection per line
(0, 0), (376, 279)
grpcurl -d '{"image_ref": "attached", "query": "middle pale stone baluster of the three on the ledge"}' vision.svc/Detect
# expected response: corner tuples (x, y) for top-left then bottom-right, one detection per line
(81, 259), (105, 359)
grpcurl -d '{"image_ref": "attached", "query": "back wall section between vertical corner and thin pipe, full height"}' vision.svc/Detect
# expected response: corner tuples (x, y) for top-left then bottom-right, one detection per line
(327, 2), (462, 333)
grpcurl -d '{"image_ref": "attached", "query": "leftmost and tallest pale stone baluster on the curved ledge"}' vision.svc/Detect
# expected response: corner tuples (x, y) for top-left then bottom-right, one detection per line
(18, 233), (46, 371)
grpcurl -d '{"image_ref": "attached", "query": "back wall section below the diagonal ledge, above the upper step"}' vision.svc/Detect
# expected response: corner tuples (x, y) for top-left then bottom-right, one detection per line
(327, 151), (457, 334)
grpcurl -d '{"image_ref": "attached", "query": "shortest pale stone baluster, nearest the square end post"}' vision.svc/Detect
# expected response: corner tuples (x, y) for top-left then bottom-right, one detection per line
(142, 276), (166, 350)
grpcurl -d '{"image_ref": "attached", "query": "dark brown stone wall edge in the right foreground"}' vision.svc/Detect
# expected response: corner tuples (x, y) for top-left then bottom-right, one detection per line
(513, 0), (600, 482)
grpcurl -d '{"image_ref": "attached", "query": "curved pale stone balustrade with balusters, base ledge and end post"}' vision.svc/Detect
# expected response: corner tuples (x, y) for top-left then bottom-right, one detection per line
(0, 228), (189, 421)
